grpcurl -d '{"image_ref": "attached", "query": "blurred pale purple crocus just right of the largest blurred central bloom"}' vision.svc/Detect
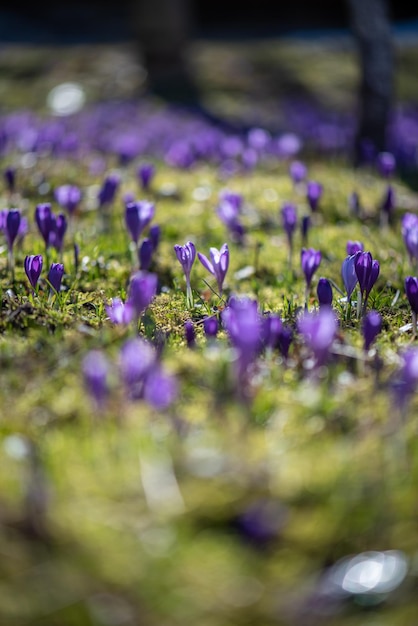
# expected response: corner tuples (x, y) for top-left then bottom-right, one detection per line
(298, 307), (337, 365)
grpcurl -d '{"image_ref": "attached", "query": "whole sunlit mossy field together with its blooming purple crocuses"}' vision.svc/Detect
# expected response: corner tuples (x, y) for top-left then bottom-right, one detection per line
(0, 40), (418, 626)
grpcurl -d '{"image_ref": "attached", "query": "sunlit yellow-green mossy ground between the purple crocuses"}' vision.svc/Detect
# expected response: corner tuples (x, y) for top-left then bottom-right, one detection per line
(0, 35), (418, 626)
